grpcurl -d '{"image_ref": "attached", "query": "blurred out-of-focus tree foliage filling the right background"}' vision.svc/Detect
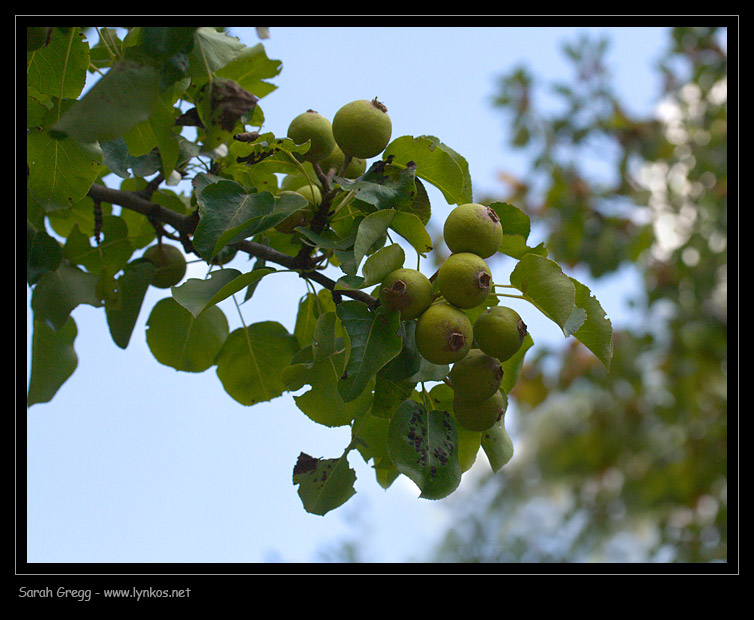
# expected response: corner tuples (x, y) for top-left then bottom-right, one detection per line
(433, 27), (728, 562)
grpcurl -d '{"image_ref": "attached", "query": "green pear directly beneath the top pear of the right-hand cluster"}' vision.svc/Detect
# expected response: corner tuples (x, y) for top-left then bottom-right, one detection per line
(437, 252), (492, 308)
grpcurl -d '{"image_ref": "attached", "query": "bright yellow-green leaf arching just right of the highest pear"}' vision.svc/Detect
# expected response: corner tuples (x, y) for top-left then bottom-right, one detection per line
(382, 136), (472, 204)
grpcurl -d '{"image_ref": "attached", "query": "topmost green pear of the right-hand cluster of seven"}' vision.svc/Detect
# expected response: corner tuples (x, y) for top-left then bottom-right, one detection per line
(443, 202), (503, 258)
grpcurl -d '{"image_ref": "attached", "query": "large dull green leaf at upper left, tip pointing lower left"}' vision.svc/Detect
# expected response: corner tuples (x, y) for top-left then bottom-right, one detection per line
(50, 60), (160, 143)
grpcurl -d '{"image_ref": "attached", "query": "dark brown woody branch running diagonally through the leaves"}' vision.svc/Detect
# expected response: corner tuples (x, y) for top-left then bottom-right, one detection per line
(89, 183), (378, 307)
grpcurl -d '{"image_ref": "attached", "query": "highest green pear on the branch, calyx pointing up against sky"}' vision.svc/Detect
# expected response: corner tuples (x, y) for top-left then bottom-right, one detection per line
(332, 99), (393, 159)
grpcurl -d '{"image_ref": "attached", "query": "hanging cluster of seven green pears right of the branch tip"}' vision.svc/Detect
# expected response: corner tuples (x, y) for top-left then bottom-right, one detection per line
(379, 203), (526, 431)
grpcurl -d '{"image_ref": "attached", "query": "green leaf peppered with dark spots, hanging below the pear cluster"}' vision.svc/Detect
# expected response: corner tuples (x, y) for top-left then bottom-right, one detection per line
(388, 400), (462, 499)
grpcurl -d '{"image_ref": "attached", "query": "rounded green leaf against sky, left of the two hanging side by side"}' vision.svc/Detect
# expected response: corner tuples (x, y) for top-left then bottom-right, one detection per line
(147, 297), (228, 372)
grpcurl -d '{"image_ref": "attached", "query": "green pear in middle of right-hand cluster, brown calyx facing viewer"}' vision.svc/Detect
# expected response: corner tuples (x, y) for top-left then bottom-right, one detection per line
(416, 302), (474, 364)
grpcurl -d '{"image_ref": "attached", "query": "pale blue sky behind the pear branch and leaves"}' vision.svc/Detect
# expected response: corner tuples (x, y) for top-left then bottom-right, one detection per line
(26, 24), (668, 563)
